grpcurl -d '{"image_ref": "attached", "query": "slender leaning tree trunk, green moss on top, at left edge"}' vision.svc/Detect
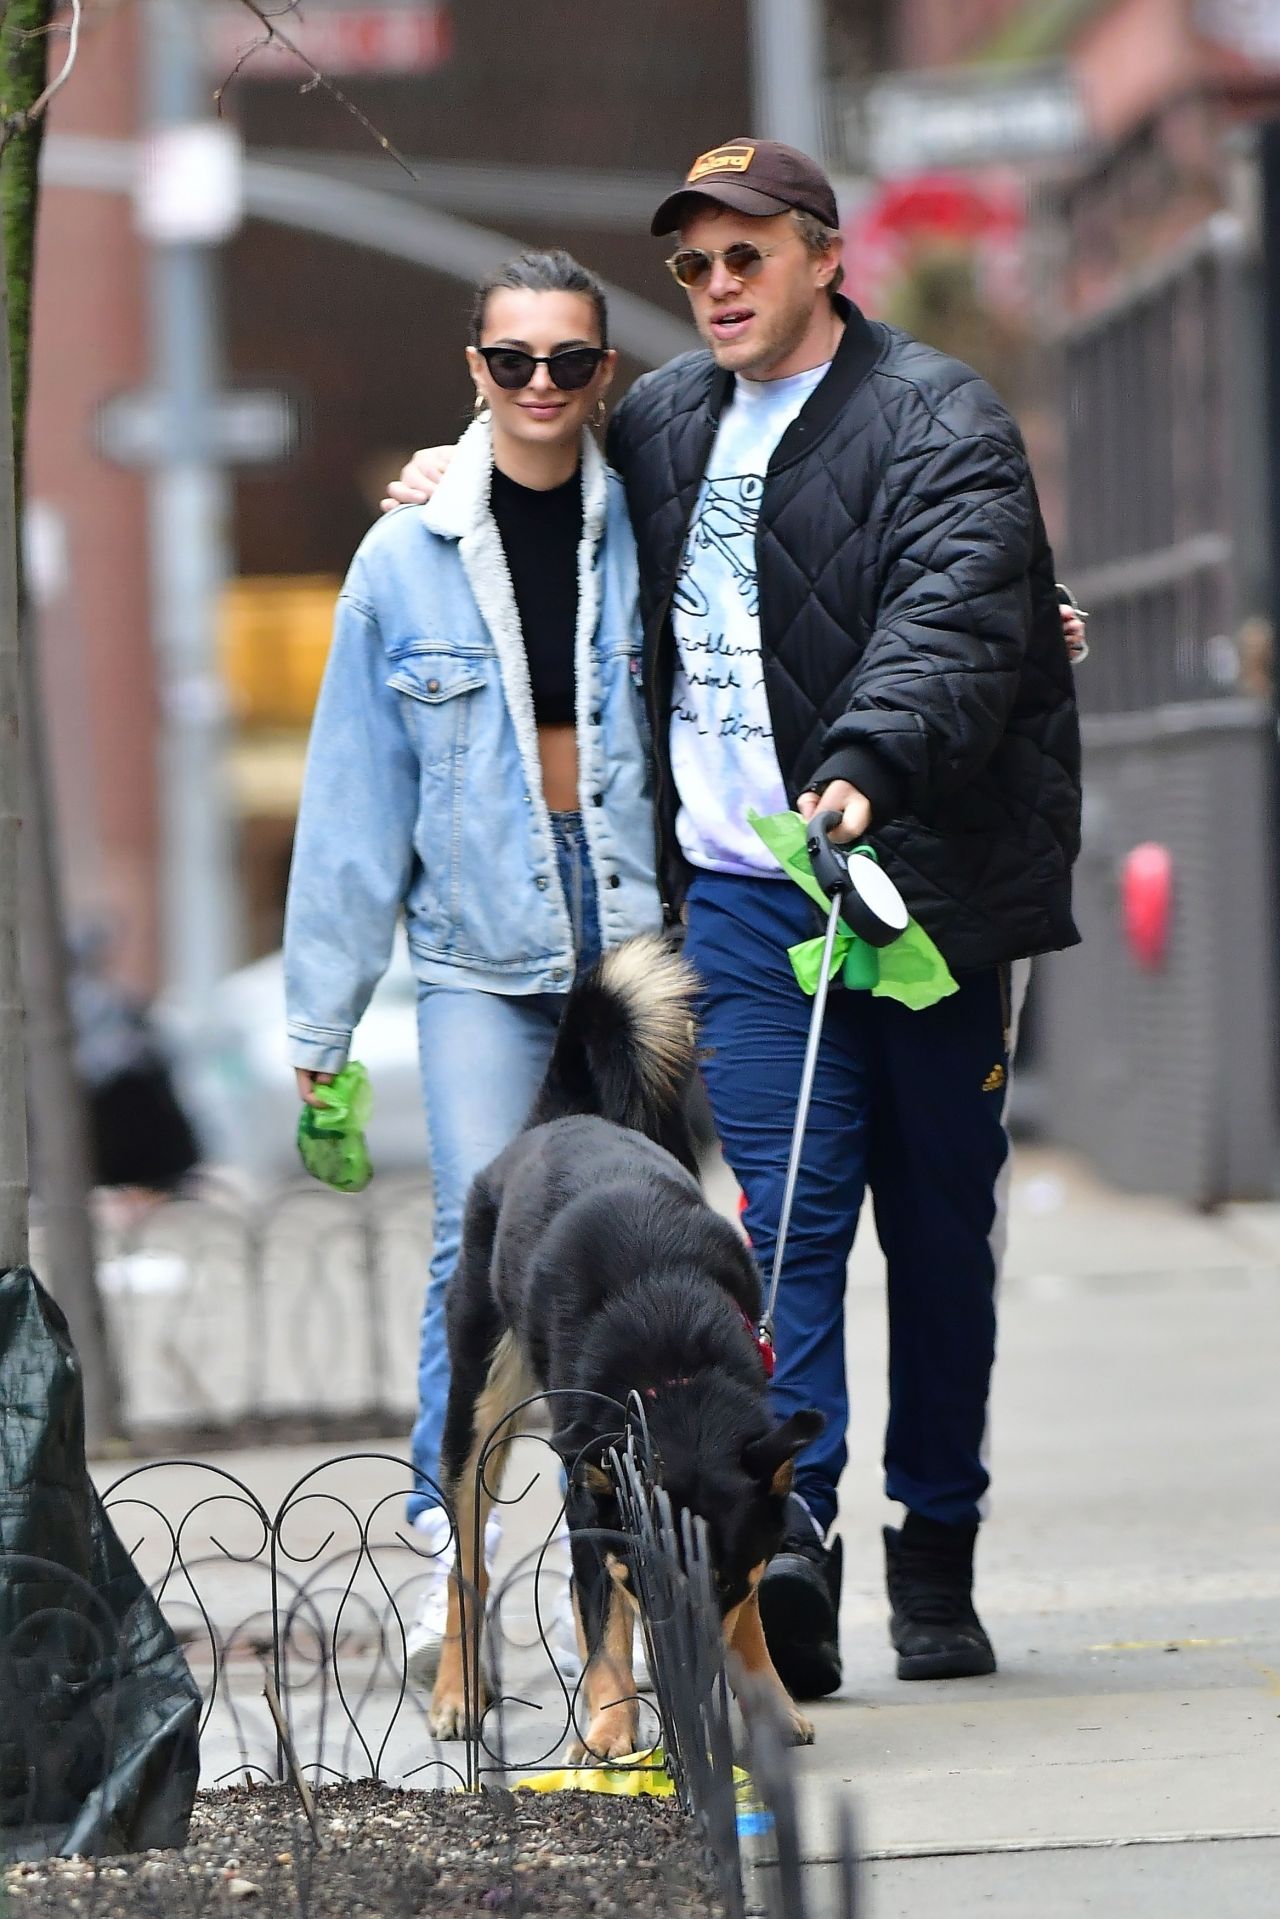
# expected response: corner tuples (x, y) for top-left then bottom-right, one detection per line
(0, 0), (121, 1449)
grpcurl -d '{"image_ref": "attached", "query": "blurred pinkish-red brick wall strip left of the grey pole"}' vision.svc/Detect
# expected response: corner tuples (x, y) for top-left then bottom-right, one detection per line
(27, 6), (157, 986)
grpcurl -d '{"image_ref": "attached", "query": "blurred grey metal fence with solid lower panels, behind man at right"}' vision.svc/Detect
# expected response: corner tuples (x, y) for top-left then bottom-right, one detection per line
(1038, 213), (1276, 1205)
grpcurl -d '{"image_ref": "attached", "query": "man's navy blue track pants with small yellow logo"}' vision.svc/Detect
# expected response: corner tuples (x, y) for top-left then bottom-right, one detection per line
(685, 873), (1009, 1531)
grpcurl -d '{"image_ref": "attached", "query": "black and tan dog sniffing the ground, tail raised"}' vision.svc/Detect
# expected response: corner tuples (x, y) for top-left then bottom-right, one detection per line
(432, 936), (821, 1758)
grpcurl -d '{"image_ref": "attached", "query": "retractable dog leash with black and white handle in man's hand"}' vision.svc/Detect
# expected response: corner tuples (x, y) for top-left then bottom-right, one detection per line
(756, 814), (910, 1378)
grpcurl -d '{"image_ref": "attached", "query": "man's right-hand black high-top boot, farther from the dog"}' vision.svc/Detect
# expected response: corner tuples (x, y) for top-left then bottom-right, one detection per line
(885, 1512), (996, 1679)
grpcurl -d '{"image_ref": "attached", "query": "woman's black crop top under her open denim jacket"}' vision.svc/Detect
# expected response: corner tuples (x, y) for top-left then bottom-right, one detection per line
(491, 466), (581, 725)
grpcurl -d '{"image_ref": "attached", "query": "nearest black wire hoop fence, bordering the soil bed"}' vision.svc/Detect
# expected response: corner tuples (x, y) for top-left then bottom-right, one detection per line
(0, 1401), (856, 1919)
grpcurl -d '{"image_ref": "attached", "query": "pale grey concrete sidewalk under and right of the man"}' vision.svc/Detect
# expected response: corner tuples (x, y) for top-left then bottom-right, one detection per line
(98, 1151), (1280, 1919)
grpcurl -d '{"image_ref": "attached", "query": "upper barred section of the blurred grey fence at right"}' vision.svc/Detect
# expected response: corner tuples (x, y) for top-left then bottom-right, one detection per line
(1061, 215), (1263, 720)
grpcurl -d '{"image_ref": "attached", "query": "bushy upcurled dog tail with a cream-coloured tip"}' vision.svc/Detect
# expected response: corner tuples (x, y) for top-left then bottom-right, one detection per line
(528, 933), (697, 1165)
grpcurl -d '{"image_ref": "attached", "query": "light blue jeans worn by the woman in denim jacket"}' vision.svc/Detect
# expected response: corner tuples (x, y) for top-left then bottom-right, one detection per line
(407, 814), (601, 1524)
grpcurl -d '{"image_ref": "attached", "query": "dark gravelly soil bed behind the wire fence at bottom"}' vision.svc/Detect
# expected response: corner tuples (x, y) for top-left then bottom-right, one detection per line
(0, 1781), (723, 1919)
